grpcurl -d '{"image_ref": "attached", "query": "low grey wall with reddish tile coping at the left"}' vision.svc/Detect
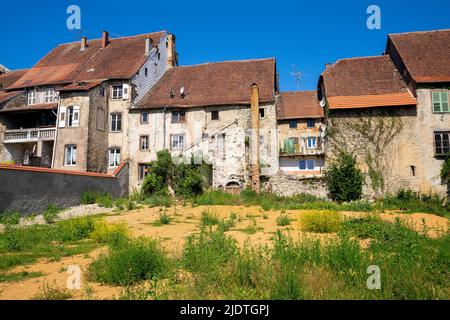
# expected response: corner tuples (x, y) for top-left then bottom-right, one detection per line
(0, 163), (128, 215)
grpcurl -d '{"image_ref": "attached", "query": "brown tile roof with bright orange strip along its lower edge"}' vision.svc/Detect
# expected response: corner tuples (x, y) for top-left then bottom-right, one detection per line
(322, 55), (416, 109)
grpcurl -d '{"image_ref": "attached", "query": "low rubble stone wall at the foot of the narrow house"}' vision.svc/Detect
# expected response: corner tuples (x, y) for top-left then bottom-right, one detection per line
(264, 171), (328, 198)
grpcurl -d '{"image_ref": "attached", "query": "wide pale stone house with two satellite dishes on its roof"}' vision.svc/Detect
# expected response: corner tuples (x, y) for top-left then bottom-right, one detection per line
(128, 59), (278, 190)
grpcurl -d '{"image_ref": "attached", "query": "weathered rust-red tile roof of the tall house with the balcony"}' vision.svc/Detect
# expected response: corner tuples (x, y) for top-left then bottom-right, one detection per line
(10, 31), (166, 88)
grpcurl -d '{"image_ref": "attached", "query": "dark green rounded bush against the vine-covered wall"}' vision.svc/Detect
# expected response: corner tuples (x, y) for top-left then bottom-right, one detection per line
(325, 152), (363, 202)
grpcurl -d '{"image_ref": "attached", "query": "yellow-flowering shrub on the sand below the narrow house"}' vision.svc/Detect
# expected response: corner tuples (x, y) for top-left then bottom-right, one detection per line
(300, 211), (341, 233)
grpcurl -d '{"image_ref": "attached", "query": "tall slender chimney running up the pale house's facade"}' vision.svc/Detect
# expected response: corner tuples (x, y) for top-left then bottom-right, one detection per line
(250, 83), (260, 193)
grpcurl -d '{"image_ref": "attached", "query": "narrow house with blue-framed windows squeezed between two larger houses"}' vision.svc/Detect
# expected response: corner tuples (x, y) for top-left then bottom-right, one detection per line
(277, 90), (325, 177)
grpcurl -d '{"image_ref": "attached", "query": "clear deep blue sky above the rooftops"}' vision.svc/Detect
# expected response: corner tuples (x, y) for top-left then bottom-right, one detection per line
(0, 0), (450, 91)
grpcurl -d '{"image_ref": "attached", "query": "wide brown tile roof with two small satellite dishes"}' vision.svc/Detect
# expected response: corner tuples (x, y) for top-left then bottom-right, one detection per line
(135, 58), (276, 109)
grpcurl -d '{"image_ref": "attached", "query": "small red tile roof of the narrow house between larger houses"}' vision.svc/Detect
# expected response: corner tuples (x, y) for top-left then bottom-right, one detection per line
(277, 90), (324, 120)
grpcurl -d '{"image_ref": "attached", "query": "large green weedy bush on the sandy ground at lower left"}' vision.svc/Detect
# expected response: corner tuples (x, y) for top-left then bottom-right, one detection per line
(88, 238), (168, 286)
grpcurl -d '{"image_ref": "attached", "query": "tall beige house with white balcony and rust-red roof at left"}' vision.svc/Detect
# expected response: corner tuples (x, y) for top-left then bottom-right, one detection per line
(0, 31), (177, 172)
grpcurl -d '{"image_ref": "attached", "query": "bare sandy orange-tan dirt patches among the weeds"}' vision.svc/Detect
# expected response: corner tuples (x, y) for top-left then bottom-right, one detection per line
(0, 206), (449, 300)
